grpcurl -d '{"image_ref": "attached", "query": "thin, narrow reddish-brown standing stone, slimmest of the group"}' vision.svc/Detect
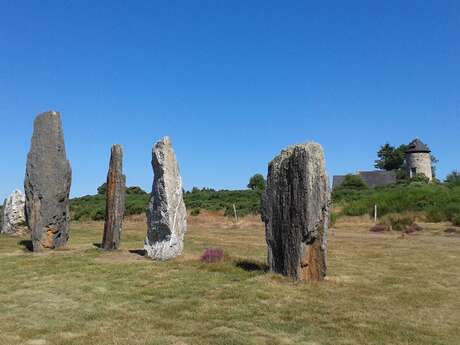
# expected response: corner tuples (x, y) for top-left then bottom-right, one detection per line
(102, 145), (126, 250)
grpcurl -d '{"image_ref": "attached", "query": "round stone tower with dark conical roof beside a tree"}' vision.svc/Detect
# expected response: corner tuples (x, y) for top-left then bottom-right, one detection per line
(406, 139), (433, 182)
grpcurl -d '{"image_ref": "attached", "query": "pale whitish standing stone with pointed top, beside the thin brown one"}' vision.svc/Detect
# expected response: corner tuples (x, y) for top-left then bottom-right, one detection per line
(144, 137), (187, 260)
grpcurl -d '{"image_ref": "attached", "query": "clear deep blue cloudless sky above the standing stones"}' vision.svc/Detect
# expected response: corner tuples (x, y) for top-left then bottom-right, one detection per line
(0, 0), (460, 198)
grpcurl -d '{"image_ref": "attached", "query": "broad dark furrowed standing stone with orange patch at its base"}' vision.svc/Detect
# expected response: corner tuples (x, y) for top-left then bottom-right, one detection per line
(262, 143), (330, 281)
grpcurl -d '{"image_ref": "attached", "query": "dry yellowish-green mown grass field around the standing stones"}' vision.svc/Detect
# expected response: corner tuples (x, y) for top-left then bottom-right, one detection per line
(0, 214), (460, 345)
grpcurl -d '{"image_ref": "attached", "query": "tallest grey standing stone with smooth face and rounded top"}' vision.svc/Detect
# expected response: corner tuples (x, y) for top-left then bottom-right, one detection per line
(24, 111), (72, 251)
